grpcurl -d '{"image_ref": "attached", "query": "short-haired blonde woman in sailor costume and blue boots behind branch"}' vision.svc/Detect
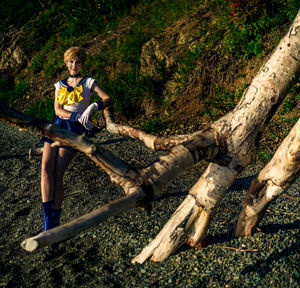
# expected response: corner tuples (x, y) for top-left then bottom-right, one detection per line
(41, 47), (113, 231)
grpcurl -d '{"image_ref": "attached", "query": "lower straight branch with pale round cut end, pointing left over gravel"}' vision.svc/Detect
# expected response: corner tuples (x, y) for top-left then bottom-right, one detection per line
(21, 189), (145, 251)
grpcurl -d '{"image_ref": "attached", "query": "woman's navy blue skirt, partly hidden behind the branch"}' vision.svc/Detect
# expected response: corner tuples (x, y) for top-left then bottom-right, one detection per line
(41, 116), (95, 150)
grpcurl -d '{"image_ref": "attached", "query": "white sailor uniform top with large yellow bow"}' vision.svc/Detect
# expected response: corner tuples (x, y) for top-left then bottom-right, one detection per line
(54, 76), (96, 119)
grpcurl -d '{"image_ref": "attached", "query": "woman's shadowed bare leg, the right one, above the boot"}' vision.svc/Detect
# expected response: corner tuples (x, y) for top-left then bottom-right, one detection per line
(53, 148), (75, 209)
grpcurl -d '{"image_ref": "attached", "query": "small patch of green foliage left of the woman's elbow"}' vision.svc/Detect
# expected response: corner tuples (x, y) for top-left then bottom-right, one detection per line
(25, 98), (55, 121)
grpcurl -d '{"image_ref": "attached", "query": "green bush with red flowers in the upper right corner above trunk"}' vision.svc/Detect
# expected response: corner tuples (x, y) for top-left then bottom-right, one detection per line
(223, 0), (299, 59)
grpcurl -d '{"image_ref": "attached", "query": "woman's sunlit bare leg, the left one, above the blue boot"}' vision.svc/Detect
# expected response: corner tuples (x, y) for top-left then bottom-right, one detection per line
(41, 142), (57, 202)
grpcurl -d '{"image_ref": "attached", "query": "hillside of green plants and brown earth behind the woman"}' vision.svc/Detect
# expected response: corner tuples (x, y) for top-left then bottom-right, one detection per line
(0, 0), (300, 160)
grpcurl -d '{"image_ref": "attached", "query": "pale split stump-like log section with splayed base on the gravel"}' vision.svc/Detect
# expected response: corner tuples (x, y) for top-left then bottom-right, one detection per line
(132, 164), (237, 263)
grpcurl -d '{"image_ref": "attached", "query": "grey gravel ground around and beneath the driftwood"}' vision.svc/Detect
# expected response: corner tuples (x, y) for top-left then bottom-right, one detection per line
(0, 122), (300, 287)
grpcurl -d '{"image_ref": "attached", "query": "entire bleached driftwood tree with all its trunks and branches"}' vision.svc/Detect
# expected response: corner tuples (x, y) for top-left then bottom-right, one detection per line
(0, 11), (300, 263)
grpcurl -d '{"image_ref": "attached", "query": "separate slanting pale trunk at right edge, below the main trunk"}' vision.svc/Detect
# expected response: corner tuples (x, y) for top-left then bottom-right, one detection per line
(235, 120), (300, 236)
